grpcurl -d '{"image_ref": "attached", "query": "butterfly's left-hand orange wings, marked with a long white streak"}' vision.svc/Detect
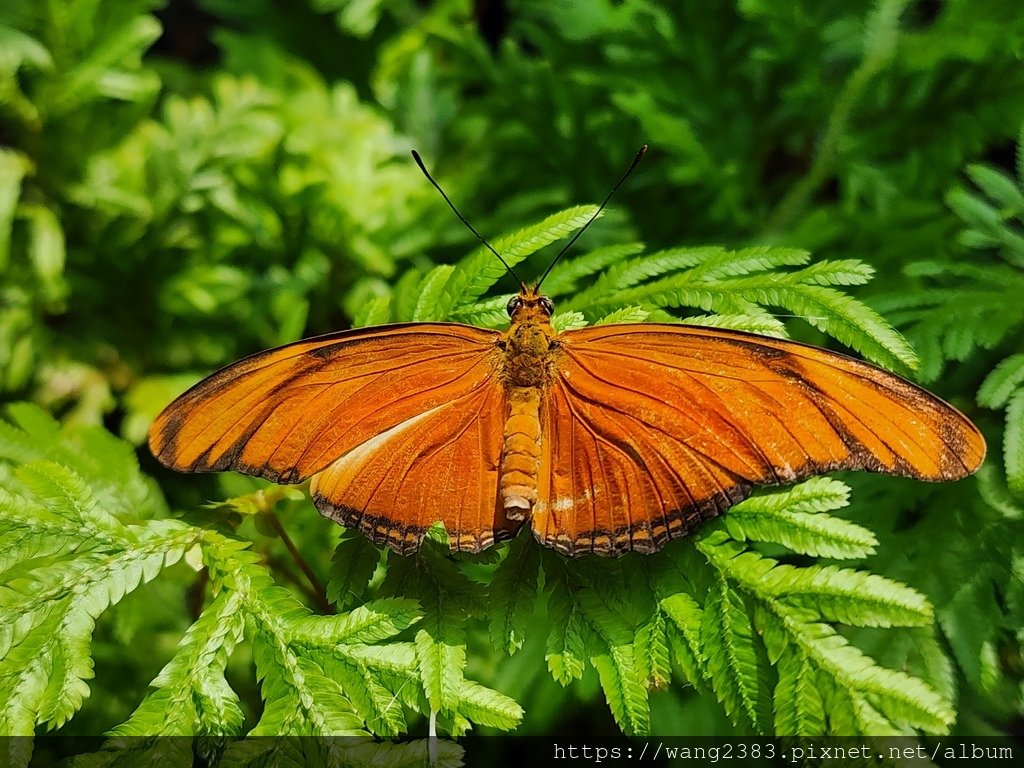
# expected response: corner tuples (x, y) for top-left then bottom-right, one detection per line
(150, 324), (518, 551)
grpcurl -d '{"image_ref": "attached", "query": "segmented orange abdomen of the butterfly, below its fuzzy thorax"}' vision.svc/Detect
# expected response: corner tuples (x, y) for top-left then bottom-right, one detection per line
(501, 387), (541, 520)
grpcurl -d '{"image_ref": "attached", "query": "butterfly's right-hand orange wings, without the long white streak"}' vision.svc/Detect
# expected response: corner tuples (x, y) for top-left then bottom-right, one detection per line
(532, 324), (985, 555)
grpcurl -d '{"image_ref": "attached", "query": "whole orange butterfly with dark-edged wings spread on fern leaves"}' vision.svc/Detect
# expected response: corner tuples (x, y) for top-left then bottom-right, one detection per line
(150, 151), (985, 555)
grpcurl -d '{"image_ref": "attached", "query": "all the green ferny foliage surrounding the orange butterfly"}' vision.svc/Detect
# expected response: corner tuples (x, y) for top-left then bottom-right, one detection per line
(0, 0), (1024, 753)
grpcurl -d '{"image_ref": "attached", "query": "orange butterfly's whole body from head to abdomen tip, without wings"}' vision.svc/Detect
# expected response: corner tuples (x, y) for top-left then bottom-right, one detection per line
(500, 290), (556, 520)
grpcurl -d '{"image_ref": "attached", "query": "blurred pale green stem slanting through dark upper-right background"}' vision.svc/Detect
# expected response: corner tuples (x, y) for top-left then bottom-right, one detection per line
(764, 0), (906, 233)
